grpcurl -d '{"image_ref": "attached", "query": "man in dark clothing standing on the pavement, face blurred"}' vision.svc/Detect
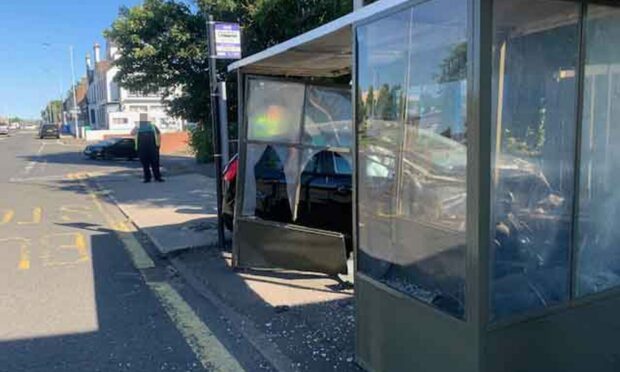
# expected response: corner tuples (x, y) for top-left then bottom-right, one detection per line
(136, 115), (164, 183)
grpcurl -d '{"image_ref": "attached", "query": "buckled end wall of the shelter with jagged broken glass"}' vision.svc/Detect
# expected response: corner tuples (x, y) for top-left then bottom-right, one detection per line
(237, 76), (353, 272)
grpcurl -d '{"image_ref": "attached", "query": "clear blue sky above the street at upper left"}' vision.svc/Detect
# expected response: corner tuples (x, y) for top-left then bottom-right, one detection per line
(0, 0), (141, 118)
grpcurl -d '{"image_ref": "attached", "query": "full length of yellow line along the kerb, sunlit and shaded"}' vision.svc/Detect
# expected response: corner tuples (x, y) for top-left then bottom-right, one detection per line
(73, 174), (244, 372)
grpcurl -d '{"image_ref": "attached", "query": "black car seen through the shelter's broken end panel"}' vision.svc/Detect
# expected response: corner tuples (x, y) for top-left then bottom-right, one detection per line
(222, 146), (353, 252)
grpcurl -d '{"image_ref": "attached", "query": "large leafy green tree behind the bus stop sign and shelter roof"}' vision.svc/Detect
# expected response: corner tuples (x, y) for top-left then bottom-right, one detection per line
(105, 0), (353, 159)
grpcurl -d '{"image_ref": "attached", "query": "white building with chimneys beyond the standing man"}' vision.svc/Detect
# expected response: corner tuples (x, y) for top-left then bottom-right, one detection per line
(87, 41), (183, 132)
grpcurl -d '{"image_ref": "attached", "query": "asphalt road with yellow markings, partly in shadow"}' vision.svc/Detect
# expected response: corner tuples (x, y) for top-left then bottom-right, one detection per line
(0, 133), (254, 371)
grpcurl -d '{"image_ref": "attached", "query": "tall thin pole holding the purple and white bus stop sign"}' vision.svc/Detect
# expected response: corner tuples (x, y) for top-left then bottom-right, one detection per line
(207, 15), (225, 249)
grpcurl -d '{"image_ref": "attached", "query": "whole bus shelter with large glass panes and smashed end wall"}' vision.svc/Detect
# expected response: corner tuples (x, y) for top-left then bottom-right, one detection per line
(230, 0), (620, 372)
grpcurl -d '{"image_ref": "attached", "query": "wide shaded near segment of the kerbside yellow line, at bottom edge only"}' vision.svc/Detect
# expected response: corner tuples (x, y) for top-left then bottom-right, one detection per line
(147, 282), (244, 372)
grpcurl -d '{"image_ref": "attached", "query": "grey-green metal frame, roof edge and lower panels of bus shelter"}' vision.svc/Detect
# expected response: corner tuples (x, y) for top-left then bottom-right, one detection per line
(229, 0), (620, 372)
